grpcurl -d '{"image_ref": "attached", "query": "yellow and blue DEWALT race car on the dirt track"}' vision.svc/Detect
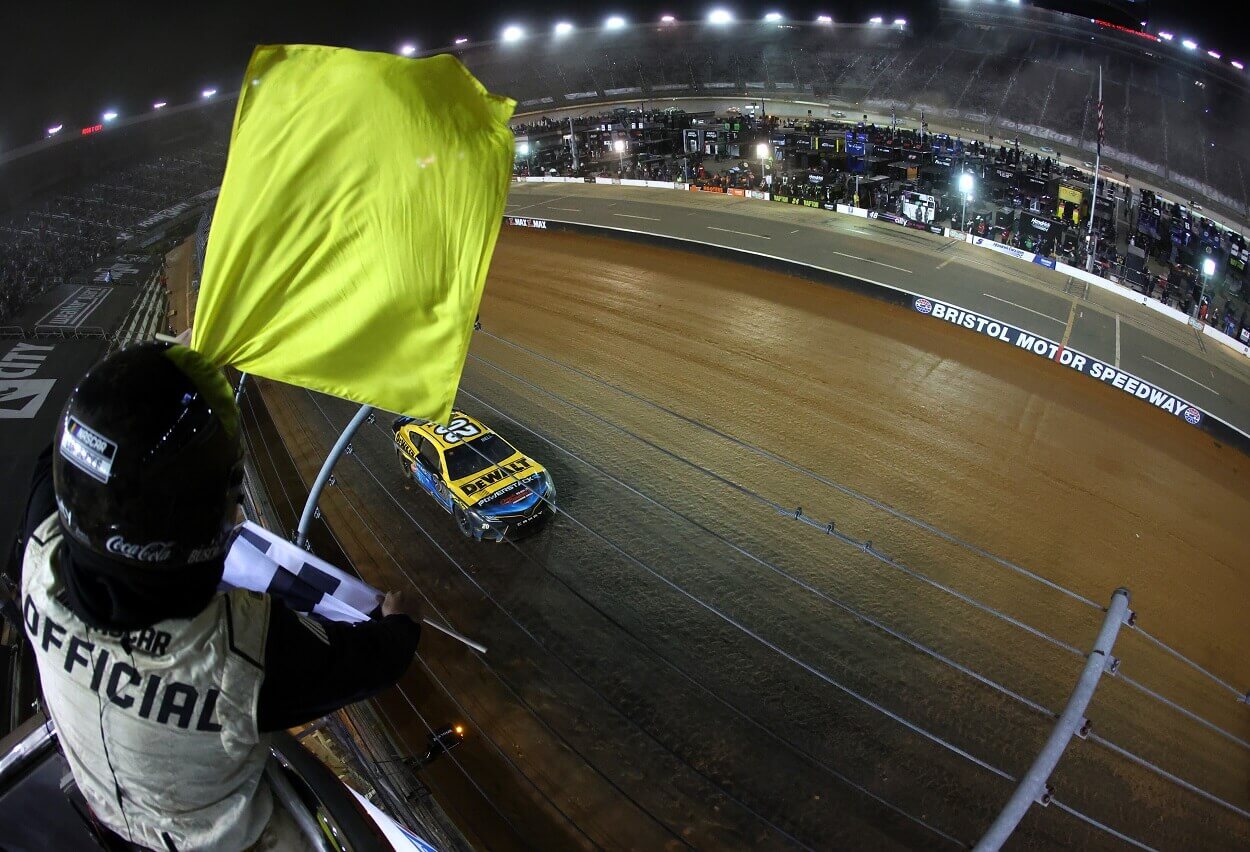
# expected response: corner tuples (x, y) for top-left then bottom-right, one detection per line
(391, 411), (555, 541)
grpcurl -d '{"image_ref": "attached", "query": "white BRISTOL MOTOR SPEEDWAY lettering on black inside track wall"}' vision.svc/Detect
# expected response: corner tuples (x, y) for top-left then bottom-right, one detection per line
(913, 296), (1205, 426)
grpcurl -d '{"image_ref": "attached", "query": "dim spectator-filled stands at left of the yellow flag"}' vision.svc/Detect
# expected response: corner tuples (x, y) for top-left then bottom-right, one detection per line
(0, 141), (226, 325)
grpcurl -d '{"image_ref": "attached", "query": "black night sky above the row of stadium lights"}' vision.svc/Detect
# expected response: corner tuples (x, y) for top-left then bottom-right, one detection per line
(0, 0), (1250, 154)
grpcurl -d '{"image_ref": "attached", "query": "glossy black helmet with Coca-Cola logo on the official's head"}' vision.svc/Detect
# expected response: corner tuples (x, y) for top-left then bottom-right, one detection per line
(53, 342), (243, 571)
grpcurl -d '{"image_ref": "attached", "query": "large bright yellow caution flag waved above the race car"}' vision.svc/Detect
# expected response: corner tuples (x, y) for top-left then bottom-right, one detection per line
(191, 45), (515, 422)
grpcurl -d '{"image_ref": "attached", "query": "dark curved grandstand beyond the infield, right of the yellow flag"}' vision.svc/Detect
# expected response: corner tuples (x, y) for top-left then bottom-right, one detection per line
(458, 4), (1250, 219)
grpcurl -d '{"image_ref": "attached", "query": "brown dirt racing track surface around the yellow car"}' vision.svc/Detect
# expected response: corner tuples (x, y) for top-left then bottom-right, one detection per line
(258, 229), (1250, 850)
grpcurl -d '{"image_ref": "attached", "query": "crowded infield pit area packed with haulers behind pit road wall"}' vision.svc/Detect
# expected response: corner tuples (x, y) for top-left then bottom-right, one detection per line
(516, 109), (1250, 342)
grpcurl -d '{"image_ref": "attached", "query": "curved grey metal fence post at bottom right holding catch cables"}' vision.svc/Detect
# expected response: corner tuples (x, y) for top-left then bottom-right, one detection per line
(974, 588), (1130, 852)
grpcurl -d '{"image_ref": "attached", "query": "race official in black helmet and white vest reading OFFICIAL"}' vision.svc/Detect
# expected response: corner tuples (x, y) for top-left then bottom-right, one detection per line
(21, 344), (420, 850)
